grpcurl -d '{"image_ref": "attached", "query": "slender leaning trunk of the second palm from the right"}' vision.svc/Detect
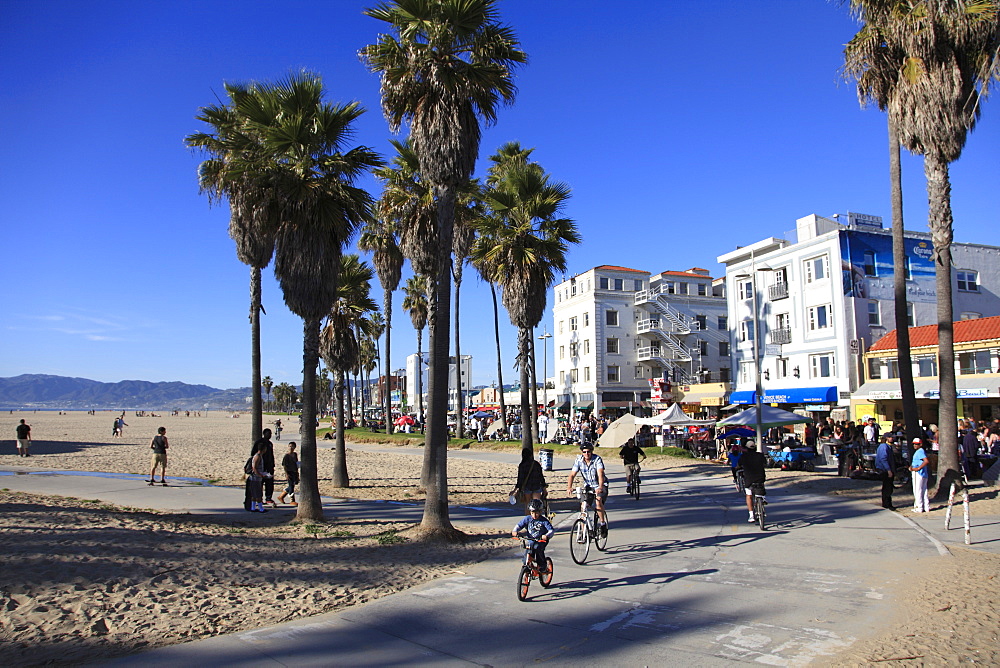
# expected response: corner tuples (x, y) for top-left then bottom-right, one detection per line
(886, 114), (920, 450)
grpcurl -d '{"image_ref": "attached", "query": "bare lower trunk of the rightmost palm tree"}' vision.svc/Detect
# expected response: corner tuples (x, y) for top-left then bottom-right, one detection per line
(924, 152), (960, 498)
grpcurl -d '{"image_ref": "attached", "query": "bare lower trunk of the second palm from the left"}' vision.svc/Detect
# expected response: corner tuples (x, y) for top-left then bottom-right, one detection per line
(295, 318), (323, 521)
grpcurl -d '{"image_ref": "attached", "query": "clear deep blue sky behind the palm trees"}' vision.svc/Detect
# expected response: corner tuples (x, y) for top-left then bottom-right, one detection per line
(0, 0), (1000, 388)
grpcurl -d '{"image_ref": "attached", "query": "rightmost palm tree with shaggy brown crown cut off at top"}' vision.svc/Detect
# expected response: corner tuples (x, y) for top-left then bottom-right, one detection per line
(852, 0), (1000, 496)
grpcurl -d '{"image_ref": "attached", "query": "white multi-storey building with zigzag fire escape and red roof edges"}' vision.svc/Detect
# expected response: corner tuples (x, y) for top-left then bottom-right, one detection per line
(553, 265), (730, 412)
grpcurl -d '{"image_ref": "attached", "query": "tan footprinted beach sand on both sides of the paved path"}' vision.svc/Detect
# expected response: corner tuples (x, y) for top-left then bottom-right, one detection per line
(0, 412), (1000, 666)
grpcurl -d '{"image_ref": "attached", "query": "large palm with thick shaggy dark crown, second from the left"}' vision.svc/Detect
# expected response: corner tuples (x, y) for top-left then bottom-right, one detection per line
(221, 73), (381, 521)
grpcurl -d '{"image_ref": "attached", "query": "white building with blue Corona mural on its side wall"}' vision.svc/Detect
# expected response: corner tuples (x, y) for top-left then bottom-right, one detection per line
(718, 213), (1000, 411)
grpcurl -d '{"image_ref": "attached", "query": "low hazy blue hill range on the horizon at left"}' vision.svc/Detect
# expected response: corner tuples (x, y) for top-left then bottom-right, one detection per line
(0, 374), (250, 410)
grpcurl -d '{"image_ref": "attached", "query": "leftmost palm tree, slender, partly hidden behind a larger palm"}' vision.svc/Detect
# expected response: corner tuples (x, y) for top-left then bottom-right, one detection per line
(184, 84), (280, 441)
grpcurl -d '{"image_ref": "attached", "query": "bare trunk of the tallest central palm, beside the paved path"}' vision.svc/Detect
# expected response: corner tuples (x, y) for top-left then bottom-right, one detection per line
(420, 186), (461, 540)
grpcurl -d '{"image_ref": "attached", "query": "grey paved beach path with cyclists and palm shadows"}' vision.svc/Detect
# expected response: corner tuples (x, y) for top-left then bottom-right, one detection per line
(0, 446), (1000, 666)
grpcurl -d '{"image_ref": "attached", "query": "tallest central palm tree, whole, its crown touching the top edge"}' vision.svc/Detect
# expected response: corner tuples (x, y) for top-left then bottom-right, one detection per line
(361, 0), (527, 537)
